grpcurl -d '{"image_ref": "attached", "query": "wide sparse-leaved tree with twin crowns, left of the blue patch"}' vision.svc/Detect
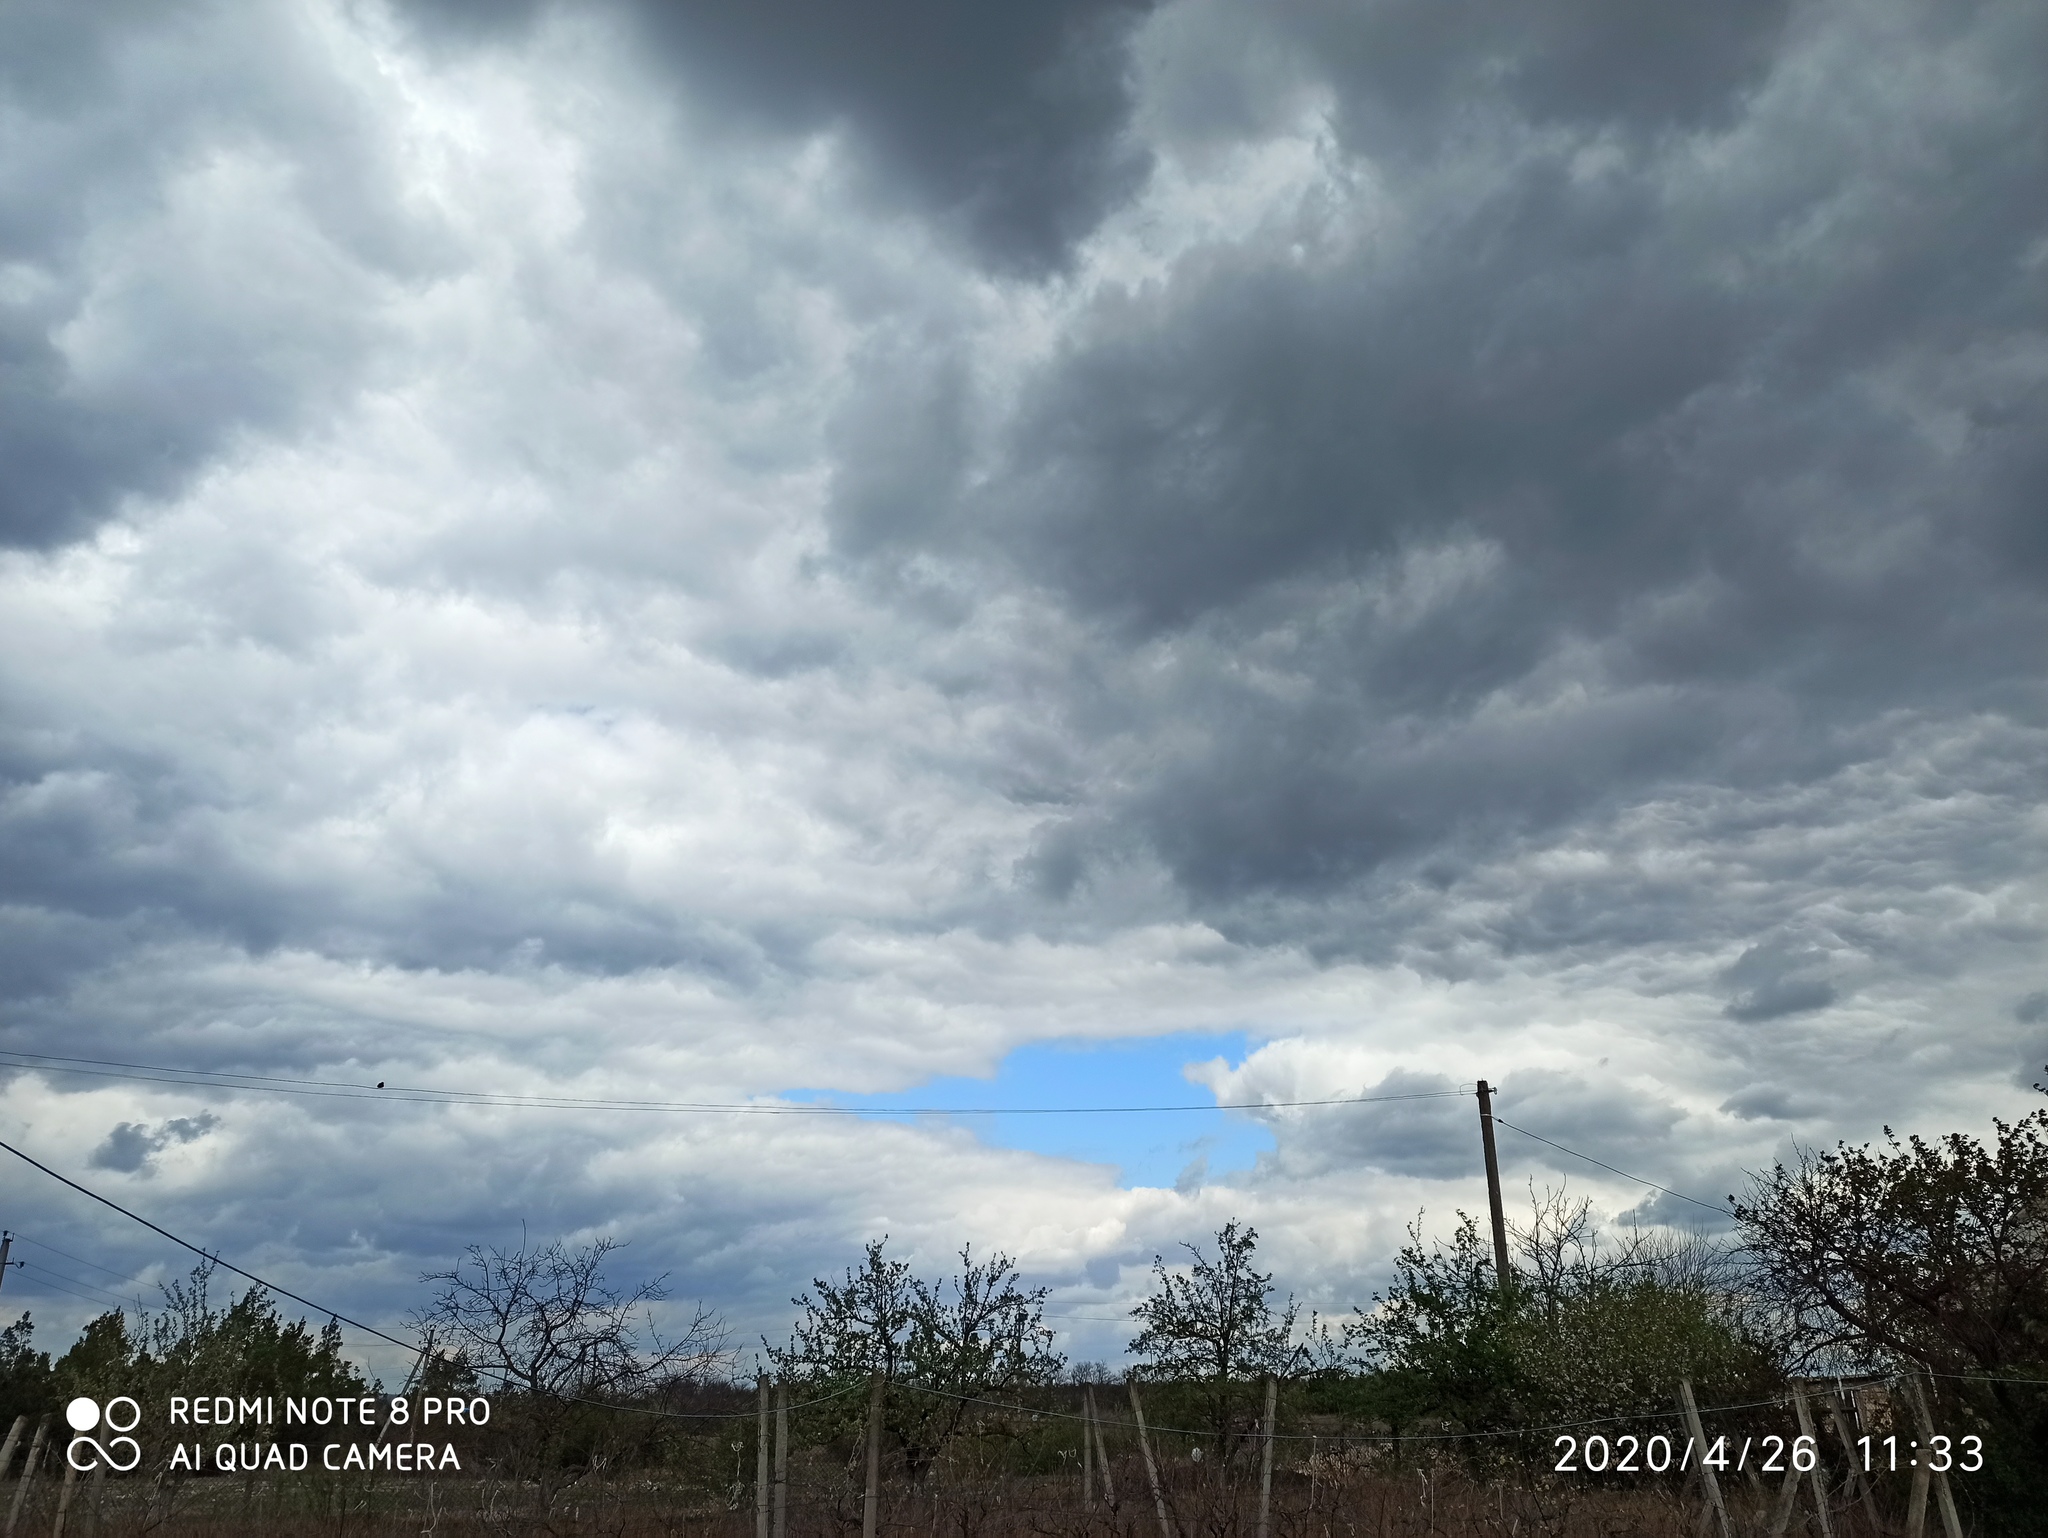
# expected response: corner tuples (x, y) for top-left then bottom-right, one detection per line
(768, 1237), (1067, 1481)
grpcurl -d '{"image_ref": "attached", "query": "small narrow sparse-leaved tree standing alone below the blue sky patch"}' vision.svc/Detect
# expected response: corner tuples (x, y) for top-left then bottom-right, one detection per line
(1128, 1219), (1298, 1468)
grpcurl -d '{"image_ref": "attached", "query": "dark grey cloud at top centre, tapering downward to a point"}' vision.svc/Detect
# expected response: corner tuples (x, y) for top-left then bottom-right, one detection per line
(406, 0), (1149, 272)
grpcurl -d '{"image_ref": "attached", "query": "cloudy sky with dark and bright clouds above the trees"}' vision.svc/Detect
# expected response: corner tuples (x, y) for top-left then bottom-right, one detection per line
(0, 0), (2048, 1372)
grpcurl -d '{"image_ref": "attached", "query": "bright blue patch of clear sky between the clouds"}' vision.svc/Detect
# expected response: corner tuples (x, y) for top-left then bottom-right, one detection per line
(795, 1030), (1274, 1188)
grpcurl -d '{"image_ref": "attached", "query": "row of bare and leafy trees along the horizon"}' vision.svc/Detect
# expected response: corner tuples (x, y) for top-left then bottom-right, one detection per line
(0, 1114), (2048, 1532)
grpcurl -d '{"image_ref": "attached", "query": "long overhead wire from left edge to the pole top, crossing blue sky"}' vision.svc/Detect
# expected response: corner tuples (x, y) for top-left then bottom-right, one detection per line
(0, 1046), (1464, 1116)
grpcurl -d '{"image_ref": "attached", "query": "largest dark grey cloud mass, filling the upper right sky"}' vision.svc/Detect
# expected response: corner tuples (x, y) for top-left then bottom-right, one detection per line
(836, 6), (2048, 946)
